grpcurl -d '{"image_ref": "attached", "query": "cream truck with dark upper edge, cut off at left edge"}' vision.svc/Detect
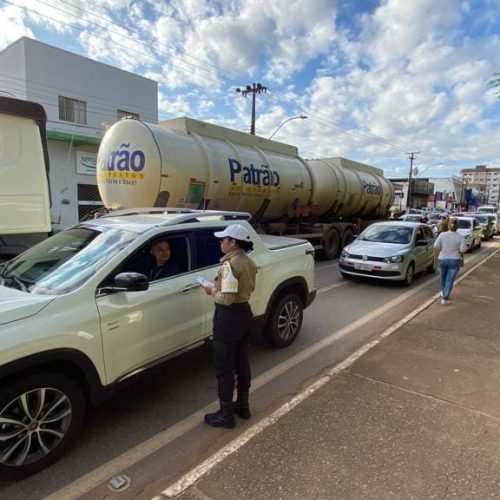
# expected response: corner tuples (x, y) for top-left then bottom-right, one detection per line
(0, 96), (51, 261)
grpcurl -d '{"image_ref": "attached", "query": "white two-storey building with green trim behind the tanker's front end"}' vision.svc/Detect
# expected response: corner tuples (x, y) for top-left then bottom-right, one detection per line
(0, 38), (158, 231)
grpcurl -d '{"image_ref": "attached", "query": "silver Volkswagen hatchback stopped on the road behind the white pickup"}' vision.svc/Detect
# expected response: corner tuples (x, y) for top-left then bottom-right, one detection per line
(339, 221), (436, 286)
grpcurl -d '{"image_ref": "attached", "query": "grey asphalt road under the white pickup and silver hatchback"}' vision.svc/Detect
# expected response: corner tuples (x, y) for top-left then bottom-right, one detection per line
(0, 243), (496, 500)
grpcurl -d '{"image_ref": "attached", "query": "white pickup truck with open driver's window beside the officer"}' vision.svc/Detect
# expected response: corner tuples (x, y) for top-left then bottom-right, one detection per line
(0, 208), (316, 479)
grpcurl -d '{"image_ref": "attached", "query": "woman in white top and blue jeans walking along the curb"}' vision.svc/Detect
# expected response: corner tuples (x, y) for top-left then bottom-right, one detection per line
(434, 218), (467, 305)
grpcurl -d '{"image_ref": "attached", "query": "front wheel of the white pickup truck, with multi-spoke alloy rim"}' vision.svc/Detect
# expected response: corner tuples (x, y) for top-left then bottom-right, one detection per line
(0, 373), (85, 480)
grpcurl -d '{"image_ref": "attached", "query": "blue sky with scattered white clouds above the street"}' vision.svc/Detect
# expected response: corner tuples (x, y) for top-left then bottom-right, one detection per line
(0, 0), (500, 177)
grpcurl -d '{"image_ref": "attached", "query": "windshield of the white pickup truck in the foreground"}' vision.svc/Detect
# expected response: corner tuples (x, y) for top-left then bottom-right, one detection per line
(0, 227), (137, 295)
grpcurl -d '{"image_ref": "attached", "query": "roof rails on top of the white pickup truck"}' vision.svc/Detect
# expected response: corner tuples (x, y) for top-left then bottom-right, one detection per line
(102, 207), (252, 225)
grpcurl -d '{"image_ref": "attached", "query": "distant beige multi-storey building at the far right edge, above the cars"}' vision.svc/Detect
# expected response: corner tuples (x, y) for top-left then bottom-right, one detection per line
(460, 165), (500, 206)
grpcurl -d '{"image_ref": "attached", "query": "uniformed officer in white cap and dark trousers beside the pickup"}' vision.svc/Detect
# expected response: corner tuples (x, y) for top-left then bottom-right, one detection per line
(203, 224), (257, 429)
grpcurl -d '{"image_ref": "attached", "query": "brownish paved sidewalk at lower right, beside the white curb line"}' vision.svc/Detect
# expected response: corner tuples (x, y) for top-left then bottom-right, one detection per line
(172, 248), (500, 500)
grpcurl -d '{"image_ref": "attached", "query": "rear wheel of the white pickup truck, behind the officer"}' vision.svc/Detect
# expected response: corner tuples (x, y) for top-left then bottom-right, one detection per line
(264, 293), (304, 347)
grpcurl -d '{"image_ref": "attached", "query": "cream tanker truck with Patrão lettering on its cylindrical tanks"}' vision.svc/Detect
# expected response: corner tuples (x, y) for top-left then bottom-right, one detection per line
(97, 117), (394, 259)
